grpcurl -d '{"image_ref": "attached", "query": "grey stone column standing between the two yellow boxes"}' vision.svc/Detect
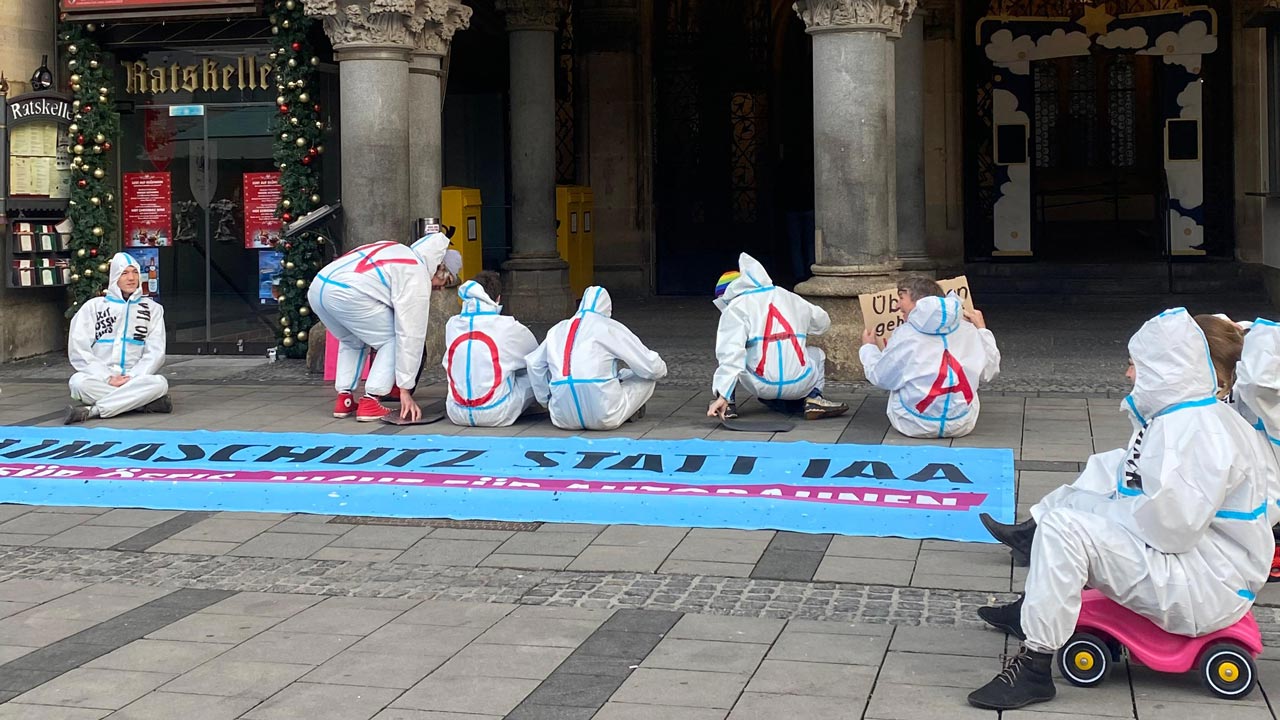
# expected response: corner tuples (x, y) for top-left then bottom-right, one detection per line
(498, 0), (572, 323)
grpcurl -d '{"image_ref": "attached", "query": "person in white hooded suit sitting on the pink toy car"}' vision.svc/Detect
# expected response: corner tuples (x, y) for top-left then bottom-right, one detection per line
(969, 309), (1274, 710)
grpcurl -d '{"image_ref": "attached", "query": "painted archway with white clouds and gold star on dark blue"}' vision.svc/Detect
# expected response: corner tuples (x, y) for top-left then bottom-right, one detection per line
(975, 0), (1219, 256)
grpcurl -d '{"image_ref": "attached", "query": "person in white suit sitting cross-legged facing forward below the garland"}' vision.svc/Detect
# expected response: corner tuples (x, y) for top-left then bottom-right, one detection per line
(65, 252), (173, 424)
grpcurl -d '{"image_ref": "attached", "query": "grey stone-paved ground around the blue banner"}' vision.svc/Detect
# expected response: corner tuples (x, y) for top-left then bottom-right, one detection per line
(0, 288), (1280, 720)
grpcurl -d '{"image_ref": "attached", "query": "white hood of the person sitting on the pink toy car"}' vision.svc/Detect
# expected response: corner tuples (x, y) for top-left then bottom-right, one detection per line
(1124, 307), (1217, 425)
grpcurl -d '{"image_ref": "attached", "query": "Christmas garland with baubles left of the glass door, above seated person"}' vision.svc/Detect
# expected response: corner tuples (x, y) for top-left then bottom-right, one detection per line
(59, 22), (120, 318)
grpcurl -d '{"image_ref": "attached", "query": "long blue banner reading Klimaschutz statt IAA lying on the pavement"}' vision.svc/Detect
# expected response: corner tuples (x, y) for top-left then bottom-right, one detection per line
(0, 427), (1014, 542)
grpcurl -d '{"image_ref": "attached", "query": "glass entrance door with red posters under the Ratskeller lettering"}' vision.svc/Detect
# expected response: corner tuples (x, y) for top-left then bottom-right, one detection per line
(122, 102), (279, 355)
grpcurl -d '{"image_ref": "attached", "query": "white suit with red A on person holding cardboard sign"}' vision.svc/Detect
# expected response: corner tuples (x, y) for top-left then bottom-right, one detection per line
(858, 296), (1000, 438)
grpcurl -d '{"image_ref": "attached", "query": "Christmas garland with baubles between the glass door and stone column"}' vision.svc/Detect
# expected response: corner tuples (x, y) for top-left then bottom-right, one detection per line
(270, 0), (324, 357)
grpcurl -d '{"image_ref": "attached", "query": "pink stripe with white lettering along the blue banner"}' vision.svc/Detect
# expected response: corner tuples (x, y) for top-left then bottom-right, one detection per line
(0, 462), (987, 511)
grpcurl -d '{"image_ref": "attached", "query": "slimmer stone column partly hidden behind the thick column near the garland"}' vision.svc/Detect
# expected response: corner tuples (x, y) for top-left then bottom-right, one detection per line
(408, 0), (471, 218)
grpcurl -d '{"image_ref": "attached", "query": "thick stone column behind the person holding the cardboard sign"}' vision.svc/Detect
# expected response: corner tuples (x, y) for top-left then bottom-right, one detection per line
(794, 0), (915, 380)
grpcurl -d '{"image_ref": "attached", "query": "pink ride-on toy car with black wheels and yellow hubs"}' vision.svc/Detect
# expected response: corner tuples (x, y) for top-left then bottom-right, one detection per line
(1057, 589), (1262, 700)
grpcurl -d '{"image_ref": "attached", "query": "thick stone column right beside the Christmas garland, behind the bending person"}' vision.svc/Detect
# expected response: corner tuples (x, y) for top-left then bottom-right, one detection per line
(305, 0), (413, 249)
